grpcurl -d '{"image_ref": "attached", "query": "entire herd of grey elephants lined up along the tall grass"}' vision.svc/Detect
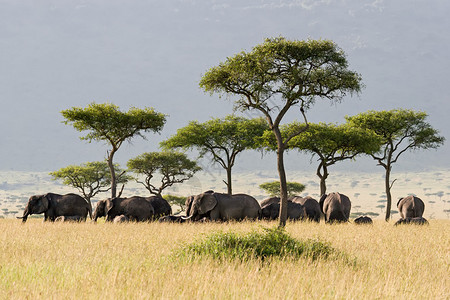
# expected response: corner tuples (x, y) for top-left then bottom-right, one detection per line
(18, 191), (428, 225)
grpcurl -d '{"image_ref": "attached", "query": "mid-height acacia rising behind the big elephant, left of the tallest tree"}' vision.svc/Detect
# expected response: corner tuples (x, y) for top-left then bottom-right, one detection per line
(161, 115), (268, 195)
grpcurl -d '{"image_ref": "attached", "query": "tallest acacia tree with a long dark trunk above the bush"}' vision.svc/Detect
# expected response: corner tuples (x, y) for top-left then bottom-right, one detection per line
(200, 37), (361, 227)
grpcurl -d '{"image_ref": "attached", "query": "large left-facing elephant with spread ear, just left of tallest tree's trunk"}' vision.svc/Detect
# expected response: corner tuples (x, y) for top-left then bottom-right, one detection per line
(185, 191), (261, 221)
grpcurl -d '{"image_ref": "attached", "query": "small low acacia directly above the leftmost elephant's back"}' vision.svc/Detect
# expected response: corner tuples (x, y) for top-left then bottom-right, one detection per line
(50, 161), (131, 203)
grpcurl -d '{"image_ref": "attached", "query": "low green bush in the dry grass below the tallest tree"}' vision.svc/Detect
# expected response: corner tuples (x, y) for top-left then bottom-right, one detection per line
(181, 227), (348, 261)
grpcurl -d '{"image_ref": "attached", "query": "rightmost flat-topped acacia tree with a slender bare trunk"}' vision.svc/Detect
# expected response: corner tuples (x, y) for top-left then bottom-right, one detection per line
(346, 109), (445, 221)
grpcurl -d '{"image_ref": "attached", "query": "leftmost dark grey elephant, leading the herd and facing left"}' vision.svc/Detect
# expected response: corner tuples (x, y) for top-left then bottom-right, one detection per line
(17, 193), (92, 222)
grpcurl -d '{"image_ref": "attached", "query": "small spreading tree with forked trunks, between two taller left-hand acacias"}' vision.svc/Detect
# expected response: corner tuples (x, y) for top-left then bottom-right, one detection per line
(127, 151), (201, 195)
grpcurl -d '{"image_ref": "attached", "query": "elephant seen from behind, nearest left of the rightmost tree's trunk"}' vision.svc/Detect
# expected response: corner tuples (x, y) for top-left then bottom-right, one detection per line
(319, 193), (352, 223)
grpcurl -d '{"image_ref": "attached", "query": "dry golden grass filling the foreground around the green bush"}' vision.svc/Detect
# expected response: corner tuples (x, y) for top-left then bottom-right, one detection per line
(0, 219), (450, 299)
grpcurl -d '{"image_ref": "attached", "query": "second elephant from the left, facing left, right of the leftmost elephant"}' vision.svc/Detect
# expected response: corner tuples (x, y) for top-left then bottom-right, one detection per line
(93, 196), (155, 222)
